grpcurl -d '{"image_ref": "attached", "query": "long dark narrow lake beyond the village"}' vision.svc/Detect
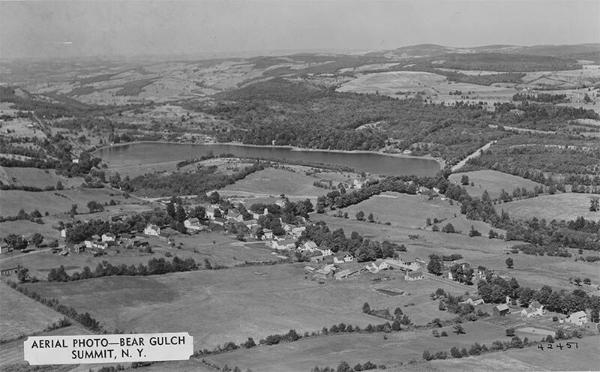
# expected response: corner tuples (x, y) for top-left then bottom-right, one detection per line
(94, 142), (440, 176)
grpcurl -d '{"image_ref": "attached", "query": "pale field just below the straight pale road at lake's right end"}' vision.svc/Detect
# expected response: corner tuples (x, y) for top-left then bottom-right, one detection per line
(449, 170), (542, 199)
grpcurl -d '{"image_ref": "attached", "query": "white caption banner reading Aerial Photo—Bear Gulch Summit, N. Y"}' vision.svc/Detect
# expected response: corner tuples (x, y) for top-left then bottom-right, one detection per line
(24, 332), (194, 365)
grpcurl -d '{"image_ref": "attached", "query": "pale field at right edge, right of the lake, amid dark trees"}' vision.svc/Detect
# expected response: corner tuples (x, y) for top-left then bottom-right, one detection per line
(496, 193), (600, 221)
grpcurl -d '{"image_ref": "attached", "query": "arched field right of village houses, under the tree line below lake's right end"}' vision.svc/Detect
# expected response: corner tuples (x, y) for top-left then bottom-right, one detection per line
(332, 192), (490, 234)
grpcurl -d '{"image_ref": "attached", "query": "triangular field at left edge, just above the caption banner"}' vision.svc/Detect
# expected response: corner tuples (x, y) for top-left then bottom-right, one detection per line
(0, 283), (63, 342)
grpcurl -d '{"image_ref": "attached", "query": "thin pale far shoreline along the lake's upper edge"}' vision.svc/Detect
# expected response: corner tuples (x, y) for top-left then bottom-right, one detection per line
(92, 141), (446, 170)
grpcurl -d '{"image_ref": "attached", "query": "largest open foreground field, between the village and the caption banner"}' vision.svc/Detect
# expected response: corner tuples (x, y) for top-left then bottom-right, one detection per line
(21, 264), (460, 349)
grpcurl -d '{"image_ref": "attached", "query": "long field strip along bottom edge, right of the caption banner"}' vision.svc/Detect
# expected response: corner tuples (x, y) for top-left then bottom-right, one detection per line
(206, 321), (508, 372)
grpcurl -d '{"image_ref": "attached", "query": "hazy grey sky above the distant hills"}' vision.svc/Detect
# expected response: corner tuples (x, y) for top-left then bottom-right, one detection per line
(0, 0), (600, 59)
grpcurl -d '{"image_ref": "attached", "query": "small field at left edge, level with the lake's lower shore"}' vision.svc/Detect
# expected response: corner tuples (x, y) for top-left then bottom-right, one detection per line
(0, 167), (83, 188)
